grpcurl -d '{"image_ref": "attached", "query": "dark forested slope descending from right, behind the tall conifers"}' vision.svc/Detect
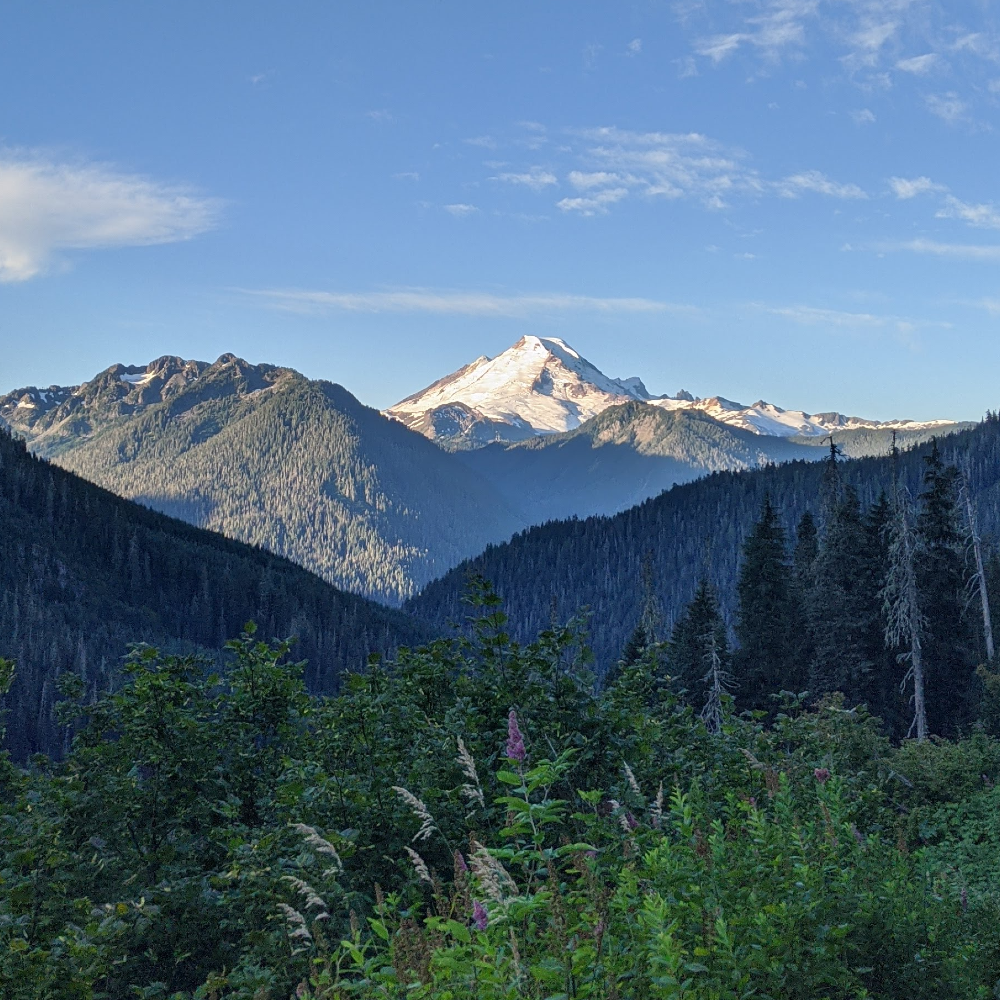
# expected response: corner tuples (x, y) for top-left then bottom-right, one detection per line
(407, 419), (1000, 684)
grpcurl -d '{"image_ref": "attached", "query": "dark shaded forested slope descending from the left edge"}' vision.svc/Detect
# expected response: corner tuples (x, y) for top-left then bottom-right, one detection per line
(0, 430), (427, 758)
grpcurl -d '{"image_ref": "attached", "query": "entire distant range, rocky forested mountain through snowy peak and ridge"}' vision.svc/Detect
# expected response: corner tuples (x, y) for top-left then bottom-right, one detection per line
(0, 336), (963, 604)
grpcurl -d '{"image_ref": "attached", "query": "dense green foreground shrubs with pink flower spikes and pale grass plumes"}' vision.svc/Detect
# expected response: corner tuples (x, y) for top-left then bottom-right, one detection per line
(0, 591), (1000, 1000)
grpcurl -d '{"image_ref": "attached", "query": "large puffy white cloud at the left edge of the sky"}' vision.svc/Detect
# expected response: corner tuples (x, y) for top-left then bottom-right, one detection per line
(0, 152), (222, 283)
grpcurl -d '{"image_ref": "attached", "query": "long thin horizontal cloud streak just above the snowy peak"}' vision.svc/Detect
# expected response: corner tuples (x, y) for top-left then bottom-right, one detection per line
(237, 288), (680, 317)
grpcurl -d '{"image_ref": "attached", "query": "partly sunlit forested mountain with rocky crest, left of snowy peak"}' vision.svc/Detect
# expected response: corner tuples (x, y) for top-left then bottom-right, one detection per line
(0, 355), (527, 604)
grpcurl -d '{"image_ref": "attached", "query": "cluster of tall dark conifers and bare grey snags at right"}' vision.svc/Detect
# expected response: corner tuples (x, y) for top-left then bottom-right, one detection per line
(622, 442), (1000, 739)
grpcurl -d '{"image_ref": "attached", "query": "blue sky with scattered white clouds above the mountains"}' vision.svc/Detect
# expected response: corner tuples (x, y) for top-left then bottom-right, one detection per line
(0, 0), (1000, 419)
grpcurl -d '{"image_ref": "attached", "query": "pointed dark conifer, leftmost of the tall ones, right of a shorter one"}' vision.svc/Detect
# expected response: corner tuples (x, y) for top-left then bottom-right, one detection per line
(735, 495), (803, 708)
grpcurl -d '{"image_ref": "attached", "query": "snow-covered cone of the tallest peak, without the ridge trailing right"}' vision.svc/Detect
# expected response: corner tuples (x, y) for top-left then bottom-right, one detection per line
(385, 336), (651, 448)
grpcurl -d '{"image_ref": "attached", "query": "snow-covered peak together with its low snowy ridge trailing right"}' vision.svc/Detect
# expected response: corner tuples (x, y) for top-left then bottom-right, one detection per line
(384, 336), (955, 450)
